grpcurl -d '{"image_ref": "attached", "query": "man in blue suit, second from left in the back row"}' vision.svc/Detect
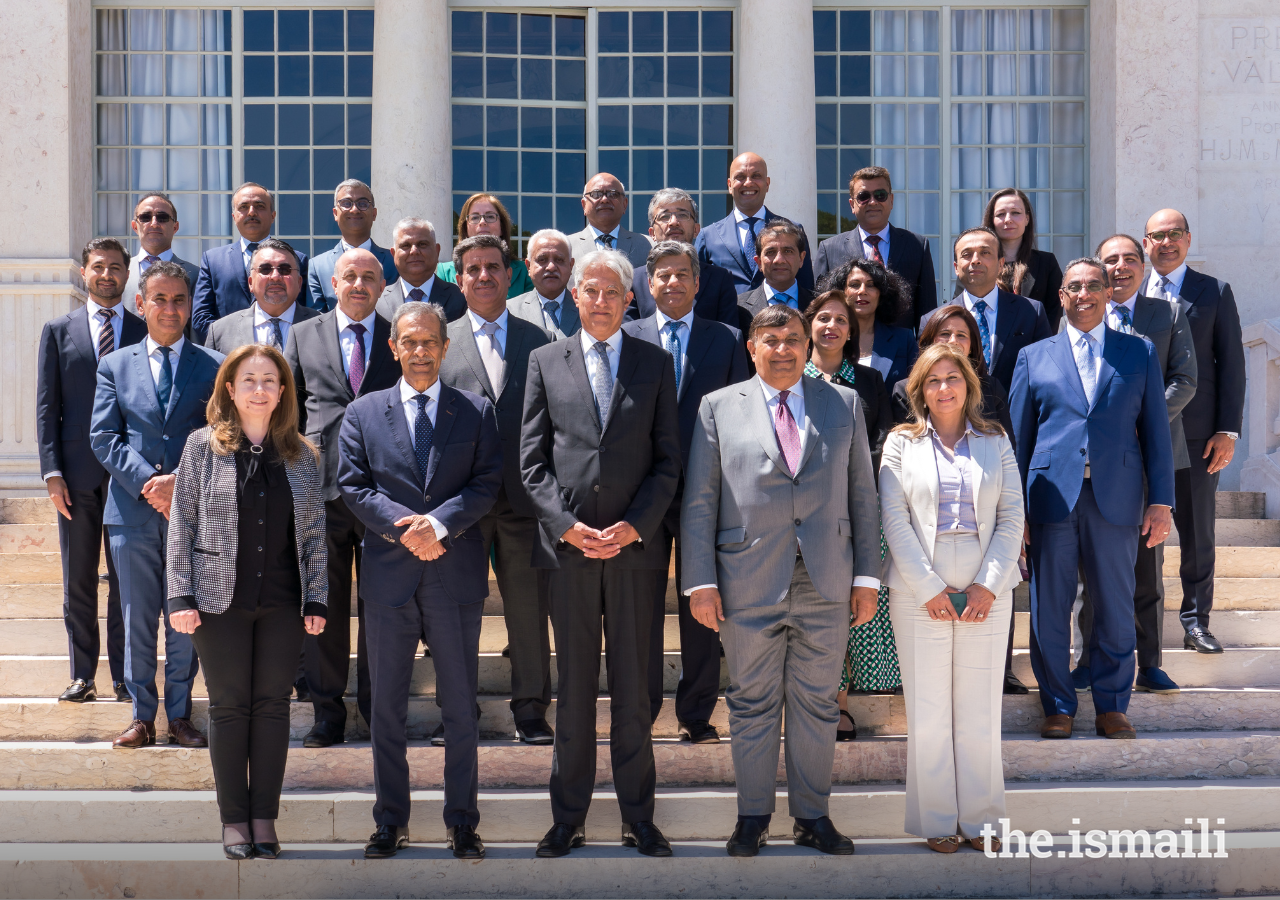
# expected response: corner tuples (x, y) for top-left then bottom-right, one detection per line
(191, 182), (315, 343)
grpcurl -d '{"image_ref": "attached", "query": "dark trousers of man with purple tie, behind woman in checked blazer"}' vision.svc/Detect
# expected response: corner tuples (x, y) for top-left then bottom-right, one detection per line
(305, 498), (370, 728)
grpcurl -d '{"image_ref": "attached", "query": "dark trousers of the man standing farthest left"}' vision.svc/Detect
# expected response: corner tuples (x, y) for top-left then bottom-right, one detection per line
(58, 478), (124, 684)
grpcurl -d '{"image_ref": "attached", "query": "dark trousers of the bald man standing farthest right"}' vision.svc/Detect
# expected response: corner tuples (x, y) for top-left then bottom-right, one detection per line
(1174, 440), (1219, 630)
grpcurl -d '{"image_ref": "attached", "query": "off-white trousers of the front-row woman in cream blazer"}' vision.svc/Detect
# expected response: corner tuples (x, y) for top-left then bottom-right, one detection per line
(888, 535), (1014, 839)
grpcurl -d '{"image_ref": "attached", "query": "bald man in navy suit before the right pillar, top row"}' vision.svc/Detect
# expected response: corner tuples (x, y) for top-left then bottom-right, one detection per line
(694, 152), (813, 293)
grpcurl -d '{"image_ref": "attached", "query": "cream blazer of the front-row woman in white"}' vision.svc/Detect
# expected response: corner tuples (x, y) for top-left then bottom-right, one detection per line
(879, 431), (1023, 604)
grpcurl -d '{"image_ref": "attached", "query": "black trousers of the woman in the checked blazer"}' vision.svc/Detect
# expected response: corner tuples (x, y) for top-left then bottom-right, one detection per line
(192, 606), (306, 824)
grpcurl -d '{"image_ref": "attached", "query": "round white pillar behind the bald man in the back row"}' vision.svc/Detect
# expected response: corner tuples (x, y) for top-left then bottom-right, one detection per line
(737, 0), (818, 236)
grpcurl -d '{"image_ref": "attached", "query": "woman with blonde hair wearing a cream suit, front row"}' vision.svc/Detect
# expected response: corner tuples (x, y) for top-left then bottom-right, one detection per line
(879, 344), (1023, 853)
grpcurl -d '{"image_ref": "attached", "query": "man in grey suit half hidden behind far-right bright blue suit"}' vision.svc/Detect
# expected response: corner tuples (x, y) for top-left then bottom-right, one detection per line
(1062, 234), (1197, 694)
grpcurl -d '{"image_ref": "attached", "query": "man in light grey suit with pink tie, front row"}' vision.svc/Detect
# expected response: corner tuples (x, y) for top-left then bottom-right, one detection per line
(680, 303), (881, 856)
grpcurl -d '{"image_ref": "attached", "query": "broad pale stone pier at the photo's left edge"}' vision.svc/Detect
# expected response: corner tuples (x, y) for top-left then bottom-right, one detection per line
(0, 0), (93, 497)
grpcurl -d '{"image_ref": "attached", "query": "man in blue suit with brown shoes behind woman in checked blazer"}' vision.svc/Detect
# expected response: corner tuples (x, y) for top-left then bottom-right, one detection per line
(90, 261), (223, 749)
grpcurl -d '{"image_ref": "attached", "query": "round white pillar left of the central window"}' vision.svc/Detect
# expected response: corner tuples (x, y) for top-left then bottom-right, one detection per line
(371, 0), (453, 245)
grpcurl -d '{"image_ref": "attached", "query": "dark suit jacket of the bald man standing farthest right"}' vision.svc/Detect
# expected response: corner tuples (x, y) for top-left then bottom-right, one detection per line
(1180, 269), (1244, 440)
